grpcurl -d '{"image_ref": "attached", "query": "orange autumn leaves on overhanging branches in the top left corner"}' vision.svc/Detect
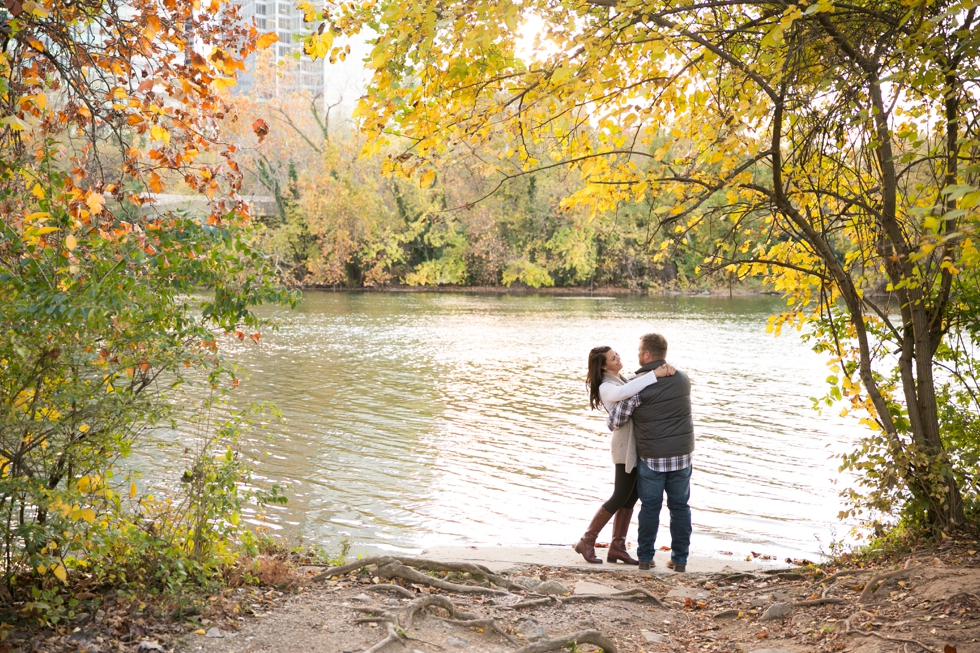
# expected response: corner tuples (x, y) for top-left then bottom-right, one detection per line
(0, 0), (277, 239)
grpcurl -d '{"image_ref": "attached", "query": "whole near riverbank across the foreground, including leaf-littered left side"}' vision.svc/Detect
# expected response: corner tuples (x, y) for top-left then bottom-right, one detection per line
(17, 537), (980, 653)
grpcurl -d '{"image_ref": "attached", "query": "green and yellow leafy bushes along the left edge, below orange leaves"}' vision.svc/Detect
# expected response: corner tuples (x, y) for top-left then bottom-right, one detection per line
(0, 148), (295, 619)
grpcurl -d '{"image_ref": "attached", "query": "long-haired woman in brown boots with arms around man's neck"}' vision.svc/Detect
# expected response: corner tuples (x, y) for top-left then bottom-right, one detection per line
(574, 347), (675, 565)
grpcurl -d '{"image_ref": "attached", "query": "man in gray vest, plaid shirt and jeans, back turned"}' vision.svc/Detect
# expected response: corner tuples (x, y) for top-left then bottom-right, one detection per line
(607, 333), (694, 572)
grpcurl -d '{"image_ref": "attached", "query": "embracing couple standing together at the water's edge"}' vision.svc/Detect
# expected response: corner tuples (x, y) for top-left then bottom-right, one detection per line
(575, 333), (694, 572)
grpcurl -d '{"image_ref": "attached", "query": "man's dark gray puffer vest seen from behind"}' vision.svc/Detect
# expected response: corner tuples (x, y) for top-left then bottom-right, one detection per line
(633, 361), (694, 458)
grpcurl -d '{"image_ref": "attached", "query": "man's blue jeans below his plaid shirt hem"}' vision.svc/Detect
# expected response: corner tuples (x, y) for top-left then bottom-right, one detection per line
(636, 460), (693, 565)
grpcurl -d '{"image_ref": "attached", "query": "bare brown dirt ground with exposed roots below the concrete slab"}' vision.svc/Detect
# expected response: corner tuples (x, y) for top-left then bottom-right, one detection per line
(178, 541), (980, 653)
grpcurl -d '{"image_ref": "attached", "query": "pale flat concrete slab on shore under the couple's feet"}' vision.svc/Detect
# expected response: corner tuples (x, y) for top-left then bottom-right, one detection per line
(419, 546), (785, 574)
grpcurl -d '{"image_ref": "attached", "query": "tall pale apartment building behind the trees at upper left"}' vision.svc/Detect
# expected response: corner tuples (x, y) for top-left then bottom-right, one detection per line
(237, 0), (327, 96)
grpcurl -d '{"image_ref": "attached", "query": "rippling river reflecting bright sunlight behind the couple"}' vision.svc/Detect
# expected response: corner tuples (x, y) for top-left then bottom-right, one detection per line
(212, 292), (862, 559)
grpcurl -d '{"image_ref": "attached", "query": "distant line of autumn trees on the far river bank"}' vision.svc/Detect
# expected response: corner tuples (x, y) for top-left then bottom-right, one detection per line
(229, 62), (752, 290)
